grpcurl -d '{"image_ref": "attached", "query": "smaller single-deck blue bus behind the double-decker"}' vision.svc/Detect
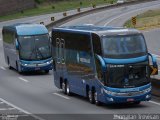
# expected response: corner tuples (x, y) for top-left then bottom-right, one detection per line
(2, 23), (53, 73)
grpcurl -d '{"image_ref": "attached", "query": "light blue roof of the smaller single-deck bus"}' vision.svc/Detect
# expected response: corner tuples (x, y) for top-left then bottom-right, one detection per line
(3, 23), (48, 35)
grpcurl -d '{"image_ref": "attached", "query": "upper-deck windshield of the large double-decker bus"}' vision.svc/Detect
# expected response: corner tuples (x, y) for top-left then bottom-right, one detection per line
(102, 34), (147, 58)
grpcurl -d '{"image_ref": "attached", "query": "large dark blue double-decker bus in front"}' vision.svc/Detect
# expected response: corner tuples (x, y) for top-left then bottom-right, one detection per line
(52, 25), (158, 105)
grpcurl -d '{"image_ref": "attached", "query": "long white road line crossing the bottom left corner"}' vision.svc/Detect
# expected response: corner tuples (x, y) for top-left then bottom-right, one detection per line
(0, 98), (45, 120)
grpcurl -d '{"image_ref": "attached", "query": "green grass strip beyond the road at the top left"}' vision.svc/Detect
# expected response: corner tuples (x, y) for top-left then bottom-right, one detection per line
(0, 0), (116, 21)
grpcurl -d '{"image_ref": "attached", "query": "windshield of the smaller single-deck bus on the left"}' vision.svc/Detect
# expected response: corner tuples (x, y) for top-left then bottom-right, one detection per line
(18, 34), (51, 60)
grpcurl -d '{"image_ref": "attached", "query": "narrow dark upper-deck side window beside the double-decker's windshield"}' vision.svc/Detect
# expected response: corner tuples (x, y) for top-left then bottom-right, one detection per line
(92, 34), (102, 55)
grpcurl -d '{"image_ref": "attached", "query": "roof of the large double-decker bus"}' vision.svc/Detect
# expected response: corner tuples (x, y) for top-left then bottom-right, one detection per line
(53, 25), (140, 36)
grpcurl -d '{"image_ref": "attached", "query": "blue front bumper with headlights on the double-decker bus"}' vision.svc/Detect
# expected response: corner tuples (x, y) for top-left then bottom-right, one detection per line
(103, 83), (151, 103)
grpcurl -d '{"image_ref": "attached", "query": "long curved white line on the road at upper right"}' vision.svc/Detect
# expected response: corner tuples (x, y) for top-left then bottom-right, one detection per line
(104, 4), (159, 26)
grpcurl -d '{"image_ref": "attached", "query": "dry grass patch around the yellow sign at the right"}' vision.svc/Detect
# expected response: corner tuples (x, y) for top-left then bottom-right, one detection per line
(124, 9), (160, 30)
